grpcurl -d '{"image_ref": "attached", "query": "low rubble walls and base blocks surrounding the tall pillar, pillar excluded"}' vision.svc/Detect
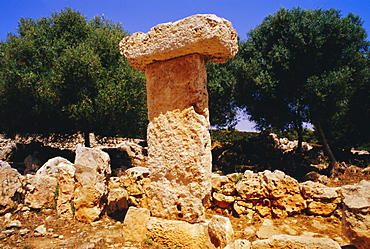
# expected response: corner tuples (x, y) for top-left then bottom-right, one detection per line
(0, 156), (370, 248)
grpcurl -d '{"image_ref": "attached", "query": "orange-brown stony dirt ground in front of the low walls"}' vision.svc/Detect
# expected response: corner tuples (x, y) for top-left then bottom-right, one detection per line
(0, 209), (355, 249)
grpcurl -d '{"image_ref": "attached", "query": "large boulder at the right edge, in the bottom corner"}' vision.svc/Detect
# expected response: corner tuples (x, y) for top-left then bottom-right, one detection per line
(341, 180), (370, 249)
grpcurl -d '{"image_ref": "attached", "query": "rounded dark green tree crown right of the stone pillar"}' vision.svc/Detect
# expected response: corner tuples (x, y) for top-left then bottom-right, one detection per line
(236, 8), (369, 160)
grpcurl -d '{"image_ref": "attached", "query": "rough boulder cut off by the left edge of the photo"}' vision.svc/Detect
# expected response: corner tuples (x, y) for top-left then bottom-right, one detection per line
(0, 161), (24, 215)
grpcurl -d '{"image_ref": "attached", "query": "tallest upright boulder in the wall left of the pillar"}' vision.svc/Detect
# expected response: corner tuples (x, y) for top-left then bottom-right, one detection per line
(73, 146), (111, 223)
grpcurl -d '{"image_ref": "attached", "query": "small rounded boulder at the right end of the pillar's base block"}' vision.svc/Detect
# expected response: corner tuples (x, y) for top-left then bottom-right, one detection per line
(208, 215), (234, 248)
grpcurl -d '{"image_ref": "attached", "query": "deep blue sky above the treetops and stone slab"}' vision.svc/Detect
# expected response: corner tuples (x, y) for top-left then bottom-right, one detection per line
(0, 0), (370, 131)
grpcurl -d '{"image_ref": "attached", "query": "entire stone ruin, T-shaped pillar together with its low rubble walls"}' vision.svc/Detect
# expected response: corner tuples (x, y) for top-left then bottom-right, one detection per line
(0, 15), (370, 249)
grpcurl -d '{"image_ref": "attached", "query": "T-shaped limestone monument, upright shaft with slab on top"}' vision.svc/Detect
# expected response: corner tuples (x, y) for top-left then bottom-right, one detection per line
(120, 14), (238, 223)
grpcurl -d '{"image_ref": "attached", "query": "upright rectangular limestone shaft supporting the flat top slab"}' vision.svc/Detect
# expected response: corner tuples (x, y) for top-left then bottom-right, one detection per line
(146, 54), (212, 222)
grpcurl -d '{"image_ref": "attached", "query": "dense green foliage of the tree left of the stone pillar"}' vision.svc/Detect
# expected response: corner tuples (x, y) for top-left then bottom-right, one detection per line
(0, 8), (146, 137)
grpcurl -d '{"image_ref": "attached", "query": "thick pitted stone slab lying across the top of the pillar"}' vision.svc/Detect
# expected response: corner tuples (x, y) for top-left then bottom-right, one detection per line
(120, 14), (238, 71)
